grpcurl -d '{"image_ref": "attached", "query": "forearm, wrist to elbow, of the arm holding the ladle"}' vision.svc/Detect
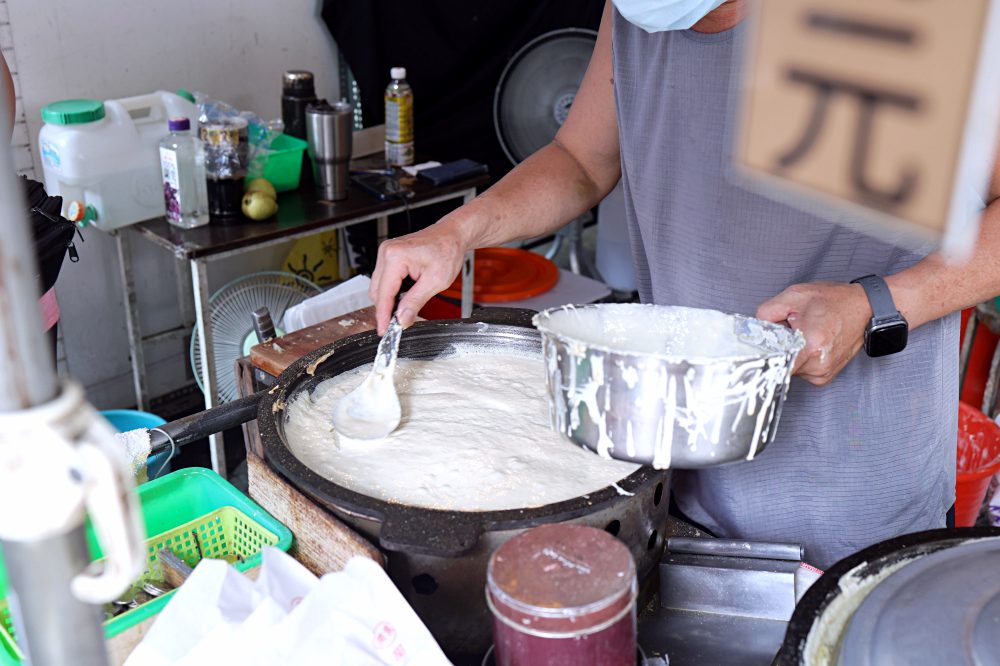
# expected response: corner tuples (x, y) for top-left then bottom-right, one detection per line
(439, 140), (620, 250)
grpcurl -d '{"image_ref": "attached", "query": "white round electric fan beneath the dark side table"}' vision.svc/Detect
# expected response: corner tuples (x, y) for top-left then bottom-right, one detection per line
(191, 271), (322, 404)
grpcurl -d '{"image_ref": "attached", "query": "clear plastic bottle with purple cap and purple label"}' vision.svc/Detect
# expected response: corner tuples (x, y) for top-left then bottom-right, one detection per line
(160, 118), (209, 229)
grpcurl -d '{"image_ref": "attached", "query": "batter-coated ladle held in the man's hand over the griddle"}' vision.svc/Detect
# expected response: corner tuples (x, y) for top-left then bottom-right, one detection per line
(333, 316), (403, 440)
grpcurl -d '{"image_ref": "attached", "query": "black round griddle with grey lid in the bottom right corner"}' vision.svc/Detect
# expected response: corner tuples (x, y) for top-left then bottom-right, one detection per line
(775, 528), (1000, 666)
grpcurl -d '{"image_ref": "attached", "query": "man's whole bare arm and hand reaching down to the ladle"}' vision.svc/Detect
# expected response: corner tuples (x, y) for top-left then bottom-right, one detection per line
(369, 2), (621, 333)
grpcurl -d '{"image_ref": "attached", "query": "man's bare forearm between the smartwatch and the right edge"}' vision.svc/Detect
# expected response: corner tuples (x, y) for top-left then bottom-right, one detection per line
(886, 200), (1000, 328)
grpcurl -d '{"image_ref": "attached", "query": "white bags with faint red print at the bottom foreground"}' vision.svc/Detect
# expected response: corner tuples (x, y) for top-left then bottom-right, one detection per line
(125, 548), (449, 666)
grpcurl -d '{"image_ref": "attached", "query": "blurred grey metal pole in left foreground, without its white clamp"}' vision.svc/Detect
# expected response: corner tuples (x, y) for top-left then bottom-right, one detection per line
(0, 85), (108, 666)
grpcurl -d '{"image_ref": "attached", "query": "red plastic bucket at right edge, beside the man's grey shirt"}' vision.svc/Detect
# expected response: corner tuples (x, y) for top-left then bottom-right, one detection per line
(955, 402), (1000, 527)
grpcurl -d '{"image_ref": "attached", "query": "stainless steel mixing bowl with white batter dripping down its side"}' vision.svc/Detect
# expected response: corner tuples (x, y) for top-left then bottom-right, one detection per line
(533, 304), (805, 469)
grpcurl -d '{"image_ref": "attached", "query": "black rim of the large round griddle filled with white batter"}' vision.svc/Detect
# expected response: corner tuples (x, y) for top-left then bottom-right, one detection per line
(257, 309), (669, 557)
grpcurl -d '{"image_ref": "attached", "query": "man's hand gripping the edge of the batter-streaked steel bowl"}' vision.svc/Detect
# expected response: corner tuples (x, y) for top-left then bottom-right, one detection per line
(757, 282), (872, 386)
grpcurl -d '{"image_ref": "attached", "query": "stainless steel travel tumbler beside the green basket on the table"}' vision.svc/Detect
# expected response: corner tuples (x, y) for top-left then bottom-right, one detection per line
(306, 100), (354, 201)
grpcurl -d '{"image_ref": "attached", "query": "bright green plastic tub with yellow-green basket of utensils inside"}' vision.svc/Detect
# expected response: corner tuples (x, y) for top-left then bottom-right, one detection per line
(0, 467), (292, 666)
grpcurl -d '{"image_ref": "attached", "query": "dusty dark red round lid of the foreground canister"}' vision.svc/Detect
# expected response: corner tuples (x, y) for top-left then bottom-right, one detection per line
(486, 524), (636, 632)
